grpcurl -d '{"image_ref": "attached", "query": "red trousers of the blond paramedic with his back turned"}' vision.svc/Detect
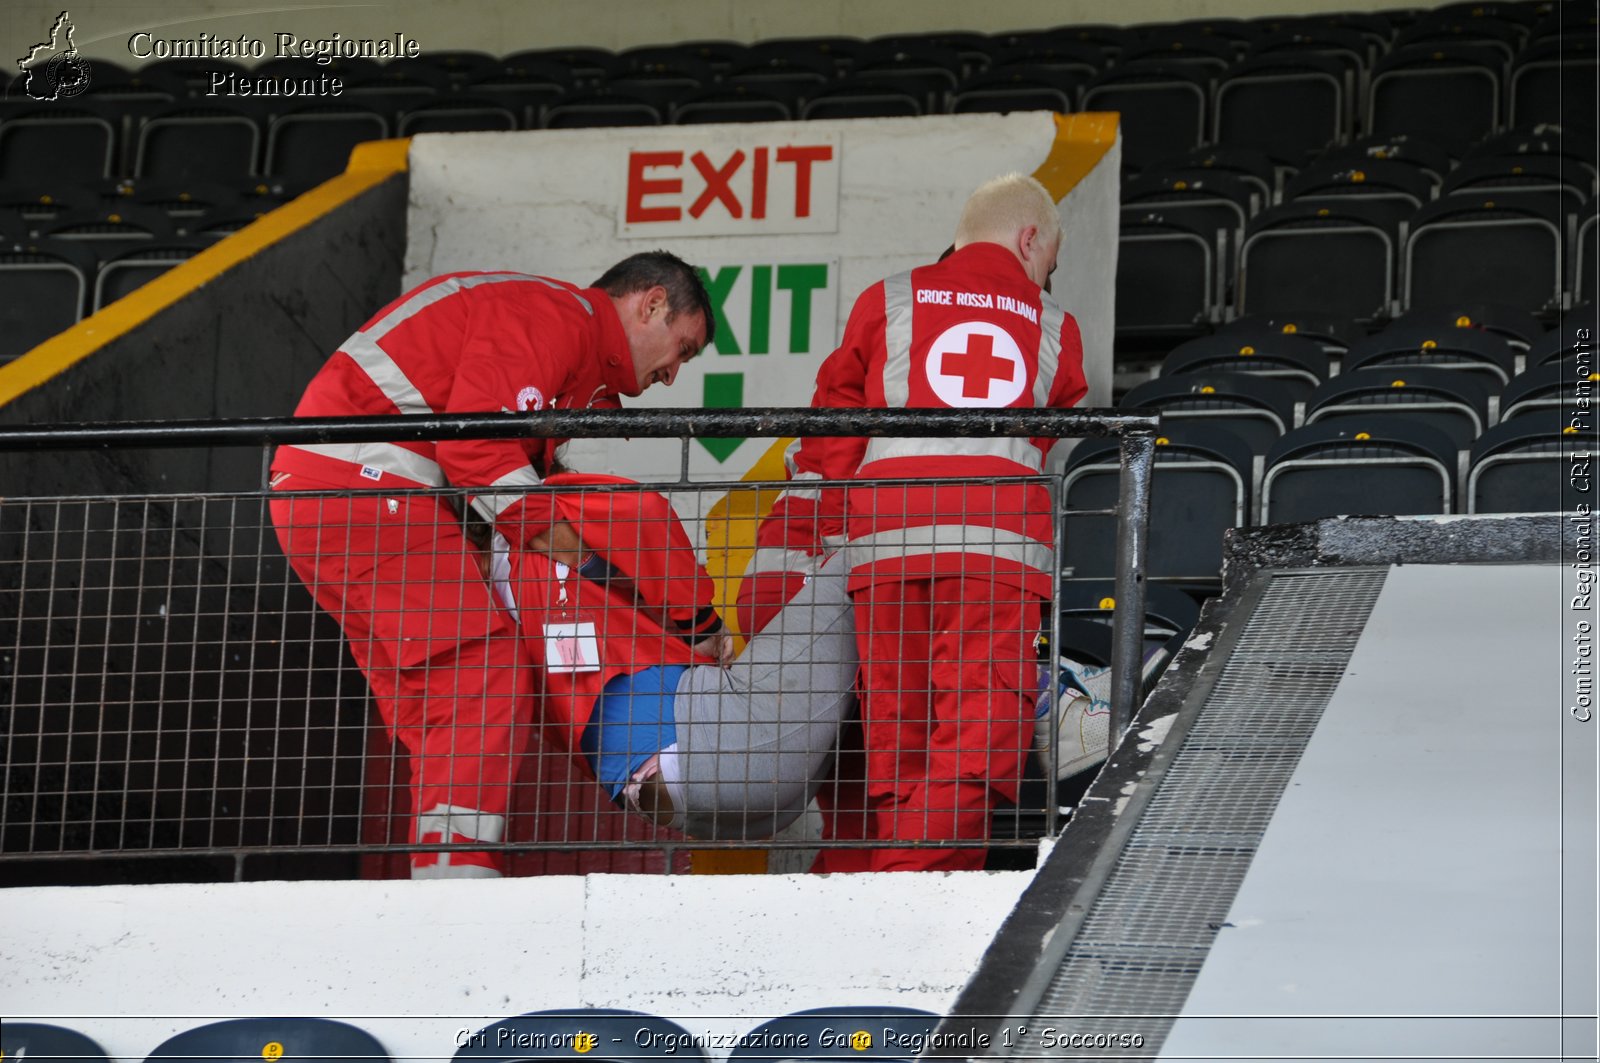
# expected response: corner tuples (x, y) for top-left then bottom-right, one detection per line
(811, 576), (1043, 872)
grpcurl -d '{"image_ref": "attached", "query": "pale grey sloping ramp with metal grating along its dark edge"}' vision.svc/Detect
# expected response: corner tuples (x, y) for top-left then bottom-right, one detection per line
(946, 517), (1597, 1060)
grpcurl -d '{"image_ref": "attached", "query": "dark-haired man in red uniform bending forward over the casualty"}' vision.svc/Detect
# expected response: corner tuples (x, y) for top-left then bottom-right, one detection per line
(272, 251), (720, 877)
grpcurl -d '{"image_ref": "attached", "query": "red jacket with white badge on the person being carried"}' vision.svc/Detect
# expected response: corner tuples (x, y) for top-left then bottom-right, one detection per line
(512, 472), (720, 760)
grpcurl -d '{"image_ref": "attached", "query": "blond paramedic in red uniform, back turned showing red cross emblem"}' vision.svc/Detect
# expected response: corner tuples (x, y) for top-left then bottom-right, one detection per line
(813, 174), (1086, 871)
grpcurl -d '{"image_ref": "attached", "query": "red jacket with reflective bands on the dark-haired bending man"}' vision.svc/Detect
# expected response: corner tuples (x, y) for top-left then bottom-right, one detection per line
(272, 272), (638, 546)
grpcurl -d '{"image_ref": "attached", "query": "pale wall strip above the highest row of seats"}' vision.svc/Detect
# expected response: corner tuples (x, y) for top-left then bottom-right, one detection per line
(0, 0), (1442, 64)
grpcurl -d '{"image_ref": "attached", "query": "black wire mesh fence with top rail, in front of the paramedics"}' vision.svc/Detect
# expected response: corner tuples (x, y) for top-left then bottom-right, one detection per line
(0, 410), (1154, 884)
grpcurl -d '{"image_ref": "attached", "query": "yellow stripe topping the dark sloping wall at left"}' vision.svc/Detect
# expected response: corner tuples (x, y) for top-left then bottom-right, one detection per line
(0, 138), (411, 405)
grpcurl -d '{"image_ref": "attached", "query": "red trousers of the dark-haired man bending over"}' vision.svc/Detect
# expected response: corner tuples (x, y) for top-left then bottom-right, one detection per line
(270, 486), (534, 877)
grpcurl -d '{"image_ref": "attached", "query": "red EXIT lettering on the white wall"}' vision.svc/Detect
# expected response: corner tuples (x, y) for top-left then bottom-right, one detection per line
(624, 144), (834, 224)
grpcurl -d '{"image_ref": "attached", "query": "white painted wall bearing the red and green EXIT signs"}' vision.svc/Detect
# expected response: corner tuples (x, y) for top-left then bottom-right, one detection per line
(405, 112), (1120, 480)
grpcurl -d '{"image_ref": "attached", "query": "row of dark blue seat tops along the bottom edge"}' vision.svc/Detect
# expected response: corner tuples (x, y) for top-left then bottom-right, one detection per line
(0, 1005), (939, 1063)
